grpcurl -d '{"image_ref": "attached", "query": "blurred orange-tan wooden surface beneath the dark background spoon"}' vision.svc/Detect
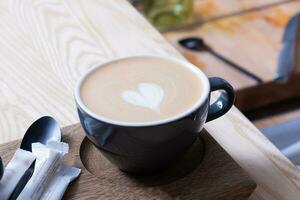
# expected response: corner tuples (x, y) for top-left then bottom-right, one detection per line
(164, 1), (300, 90)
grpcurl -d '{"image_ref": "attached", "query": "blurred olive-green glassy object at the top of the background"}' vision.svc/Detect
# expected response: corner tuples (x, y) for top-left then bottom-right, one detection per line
(129, 0), (193, 31)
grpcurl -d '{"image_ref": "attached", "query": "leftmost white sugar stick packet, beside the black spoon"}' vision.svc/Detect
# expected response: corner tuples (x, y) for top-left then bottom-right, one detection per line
(0, 149), (36, 200)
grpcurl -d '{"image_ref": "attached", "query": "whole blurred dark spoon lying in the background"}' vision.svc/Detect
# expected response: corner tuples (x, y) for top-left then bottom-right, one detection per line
(179, 37), (263, 83)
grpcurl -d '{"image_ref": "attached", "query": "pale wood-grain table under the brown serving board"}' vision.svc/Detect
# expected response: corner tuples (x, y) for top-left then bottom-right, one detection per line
(0, 0), (300, 200)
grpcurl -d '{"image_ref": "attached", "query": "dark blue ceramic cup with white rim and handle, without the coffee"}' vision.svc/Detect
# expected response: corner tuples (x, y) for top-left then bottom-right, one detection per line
(75, 56), (234, 174)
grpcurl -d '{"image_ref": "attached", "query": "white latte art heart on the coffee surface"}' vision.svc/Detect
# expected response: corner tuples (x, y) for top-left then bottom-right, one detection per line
(121, 83), (164, 112)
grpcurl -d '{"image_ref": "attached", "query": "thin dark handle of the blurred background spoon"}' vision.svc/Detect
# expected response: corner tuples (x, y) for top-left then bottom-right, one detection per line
(207, 48), (263, 83)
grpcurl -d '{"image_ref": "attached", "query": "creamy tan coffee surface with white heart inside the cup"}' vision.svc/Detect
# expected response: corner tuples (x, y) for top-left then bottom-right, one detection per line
(80, 57), (203, 123)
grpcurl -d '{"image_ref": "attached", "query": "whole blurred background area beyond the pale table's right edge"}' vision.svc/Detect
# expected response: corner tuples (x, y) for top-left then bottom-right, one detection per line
(130, 0), (300, 169)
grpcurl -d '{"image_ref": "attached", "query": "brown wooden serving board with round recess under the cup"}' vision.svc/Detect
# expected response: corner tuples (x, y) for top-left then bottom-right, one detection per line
(0, 124), (256, 200)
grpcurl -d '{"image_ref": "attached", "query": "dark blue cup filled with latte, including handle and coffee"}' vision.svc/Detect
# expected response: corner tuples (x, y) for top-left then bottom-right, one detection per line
(75, 56), (234, 174)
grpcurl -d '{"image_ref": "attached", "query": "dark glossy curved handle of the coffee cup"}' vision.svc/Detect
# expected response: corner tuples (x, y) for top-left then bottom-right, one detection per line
(206, 77), (235, 122)
